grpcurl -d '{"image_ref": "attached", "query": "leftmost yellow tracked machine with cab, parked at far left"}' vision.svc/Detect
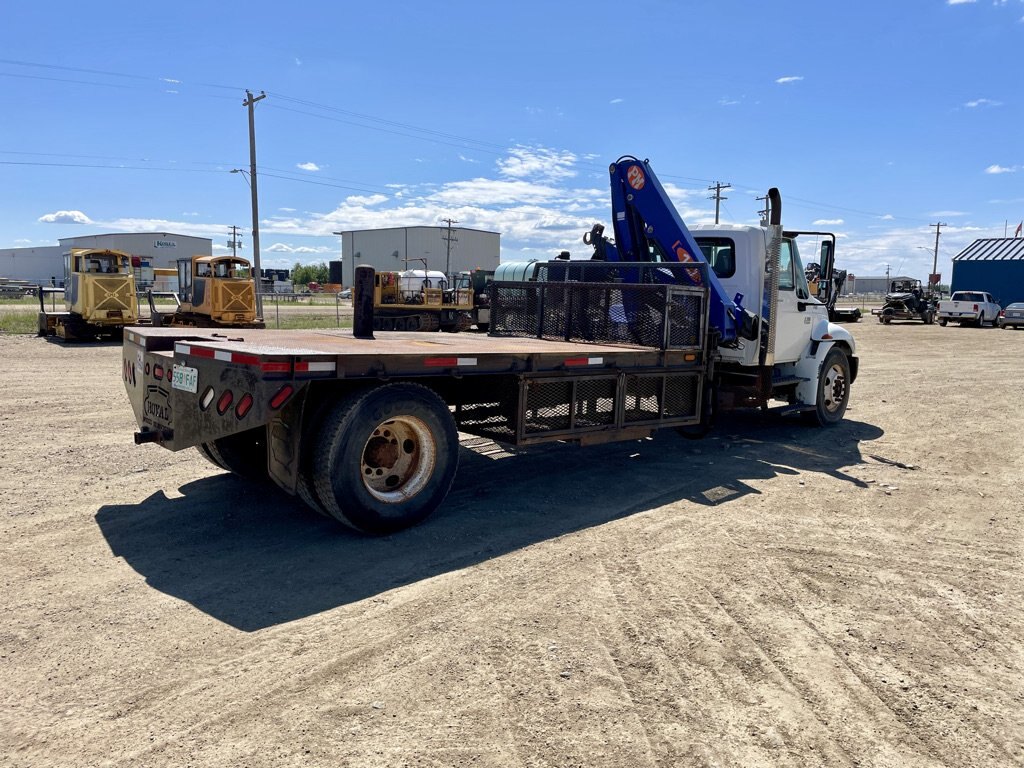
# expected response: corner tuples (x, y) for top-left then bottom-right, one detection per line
(39, 248), (138, 341)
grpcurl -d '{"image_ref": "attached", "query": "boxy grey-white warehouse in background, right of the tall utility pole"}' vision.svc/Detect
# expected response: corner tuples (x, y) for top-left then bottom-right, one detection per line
(341, 226), (501, 286)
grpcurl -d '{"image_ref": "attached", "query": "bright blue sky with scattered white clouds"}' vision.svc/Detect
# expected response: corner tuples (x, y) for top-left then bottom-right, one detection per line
(0, 0), (1024, 279)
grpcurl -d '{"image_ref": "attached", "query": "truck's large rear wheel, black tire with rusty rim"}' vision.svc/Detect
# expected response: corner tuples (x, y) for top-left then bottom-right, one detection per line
(313, 383), (459, 535)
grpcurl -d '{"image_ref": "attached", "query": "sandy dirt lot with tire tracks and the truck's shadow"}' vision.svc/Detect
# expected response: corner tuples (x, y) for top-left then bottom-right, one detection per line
(0, 322), (1024, 768)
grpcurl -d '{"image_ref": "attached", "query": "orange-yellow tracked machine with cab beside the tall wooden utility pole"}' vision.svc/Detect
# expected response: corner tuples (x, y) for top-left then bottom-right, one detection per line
(148, 256), (264, 328)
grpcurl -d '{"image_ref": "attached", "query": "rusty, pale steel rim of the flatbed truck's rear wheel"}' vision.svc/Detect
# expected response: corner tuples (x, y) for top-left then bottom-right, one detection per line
(359, 416), (437, 504)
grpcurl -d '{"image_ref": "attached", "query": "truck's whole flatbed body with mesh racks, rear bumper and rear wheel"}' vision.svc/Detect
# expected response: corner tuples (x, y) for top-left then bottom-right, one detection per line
(123, 272), (713, 534)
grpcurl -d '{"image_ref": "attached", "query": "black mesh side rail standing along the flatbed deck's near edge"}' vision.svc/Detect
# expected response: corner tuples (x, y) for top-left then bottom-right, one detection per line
(489, 282), (708, 350)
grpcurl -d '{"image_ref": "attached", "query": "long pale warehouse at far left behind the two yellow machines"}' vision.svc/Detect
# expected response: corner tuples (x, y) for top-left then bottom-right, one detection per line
(0, 232), (213, 285)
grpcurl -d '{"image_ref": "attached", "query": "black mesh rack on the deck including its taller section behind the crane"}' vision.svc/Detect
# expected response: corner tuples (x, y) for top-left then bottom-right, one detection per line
(489, 261), (708, 350)
